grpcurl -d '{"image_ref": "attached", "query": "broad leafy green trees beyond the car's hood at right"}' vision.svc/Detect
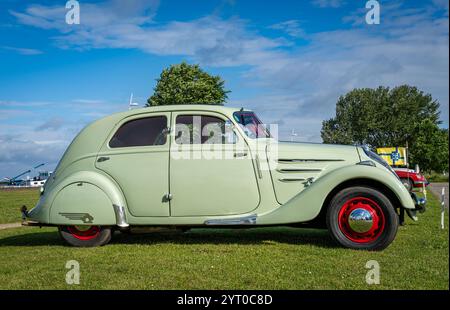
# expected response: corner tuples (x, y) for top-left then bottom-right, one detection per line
(321, 85), (448, 171)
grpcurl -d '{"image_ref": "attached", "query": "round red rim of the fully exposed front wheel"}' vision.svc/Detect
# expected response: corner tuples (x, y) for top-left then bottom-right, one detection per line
(338, 197), (386, 243)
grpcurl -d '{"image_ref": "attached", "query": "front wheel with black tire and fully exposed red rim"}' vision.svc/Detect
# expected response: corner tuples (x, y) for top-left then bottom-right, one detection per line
(326, 186), (399, 251)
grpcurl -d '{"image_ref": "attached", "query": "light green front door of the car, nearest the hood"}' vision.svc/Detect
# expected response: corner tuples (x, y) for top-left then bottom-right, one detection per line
(170, 112), (260, 216)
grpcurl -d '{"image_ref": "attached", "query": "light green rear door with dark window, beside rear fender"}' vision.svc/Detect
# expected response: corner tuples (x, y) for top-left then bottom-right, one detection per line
(95, 113), (170, 216)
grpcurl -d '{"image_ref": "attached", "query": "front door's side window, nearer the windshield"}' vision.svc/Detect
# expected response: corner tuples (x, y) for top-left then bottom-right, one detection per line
(175, 115), (237, 144)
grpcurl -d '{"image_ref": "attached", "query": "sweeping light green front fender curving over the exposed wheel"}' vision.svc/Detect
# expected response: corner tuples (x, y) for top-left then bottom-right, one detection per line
(257, 165), (415, 225)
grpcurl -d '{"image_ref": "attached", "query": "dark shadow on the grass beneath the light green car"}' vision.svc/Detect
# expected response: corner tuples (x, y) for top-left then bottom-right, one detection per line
(0, 227), (339, 248)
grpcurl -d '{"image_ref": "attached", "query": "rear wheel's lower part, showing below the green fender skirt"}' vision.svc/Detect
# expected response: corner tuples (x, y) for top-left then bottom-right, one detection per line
(58, 226), (111, 247)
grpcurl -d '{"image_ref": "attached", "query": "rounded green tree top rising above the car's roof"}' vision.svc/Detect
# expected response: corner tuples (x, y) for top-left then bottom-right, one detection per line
(147, 62), (230, 106)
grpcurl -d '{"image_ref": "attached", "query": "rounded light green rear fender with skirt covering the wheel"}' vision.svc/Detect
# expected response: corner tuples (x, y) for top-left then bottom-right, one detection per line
(28, 171), (126, 226)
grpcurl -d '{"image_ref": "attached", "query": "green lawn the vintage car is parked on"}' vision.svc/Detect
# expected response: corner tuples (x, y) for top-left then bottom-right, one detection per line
(0, 192), (449, 290)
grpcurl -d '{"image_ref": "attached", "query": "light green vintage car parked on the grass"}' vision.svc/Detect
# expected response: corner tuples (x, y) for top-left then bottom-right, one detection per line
(27, 105), (426, 250)
